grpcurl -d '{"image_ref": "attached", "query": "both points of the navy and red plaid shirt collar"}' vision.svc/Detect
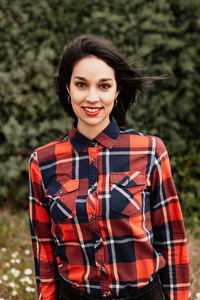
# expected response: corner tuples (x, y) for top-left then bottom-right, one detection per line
(68, 120), (120, 152)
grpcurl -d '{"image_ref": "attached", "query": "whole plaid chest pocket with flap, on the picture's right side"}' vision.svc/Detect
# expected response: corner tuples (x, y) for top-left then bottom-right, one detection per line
(110, 171), (147, 218)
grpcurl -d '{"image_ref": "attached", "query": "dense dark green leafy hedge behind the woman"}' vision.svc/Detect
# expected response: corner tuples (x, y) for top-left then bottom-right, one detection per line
(0, 0), (200, 228)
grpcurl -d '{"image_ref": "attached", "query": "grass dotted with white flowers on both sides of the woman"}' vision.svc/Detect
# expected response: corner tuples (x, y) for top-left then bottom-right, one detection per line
(0, 209), (200, 300)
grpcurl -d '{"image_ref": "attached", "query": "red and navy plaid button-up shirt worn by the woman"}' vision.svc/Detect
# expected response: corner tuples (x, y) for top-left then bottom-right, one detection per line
(30, 120), (189, 300)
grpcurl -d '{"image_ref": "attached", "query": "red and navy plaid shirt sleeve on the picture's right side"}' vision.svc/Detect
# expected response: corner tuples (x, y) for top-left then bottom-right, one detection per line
(151, 138), (190, 300)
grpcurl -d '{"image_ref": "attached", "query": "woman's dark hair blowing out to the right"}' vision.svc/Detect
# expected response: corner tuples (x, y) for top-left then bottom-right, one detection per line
(54, 35), (162, 126)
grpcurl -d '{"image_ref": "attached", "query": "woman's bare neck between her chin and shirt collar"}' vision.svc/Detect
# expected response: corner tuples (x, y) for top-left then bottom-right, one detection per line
(77, 120), (110, 140)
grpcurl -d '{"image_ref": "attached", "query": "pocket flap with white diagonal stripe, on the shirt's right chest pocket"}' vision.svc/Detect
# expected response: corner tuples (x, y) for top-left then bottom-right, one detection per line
(110, 171), (147, 187)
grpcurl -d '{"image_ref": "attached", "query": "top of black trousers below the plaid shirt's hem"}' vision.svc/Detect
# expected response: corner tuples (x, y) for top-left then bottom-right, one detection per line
(58, 277), (165, 300)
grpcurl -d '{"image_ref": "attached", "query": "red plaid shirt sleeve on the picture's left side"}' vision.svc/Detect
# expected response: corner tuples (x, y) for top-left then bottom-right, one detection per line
(29, 152), (58, 300)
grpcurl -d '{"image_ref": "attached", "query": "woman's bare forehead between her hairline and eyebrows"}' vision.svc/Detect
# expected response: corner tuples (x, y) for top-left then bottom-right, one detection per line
(72, 56), (115, 79)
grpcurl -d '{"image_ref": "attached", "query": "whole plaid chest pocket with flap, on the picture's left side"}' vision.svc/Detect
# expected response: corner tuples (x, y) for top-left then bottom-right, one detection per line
(47, 179), (79, 223)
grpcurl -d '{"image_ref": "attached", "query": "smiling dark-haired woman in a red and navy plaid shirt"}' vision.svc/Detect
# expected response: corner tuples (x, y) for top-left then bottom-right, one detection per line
(30, 35), (189, 300)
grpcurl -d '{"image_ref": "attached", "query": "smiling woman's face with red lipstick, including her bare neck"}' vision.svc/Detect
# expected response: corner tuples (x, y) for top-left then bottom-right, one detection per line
(67, 56), (119, 137)
